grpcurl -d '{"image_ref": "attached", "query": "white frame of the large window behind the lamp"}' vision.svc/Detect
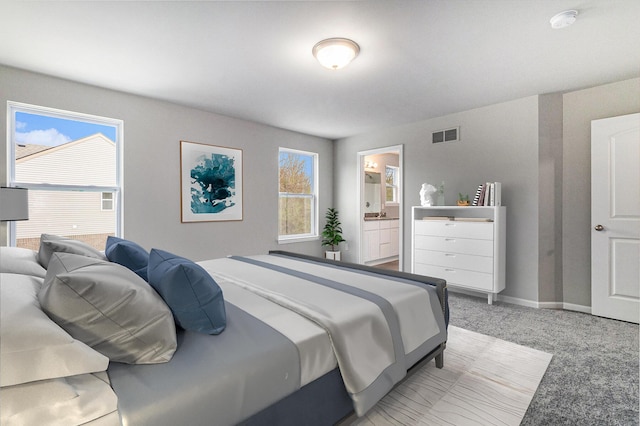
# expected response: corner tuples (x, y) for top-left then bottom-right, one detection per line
(6, 101), (124, 247)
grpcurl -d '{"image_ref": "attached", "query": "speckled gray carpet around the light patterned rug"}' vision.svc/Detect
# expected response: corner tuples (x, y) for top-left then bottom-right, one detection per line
(445, 293), (640, 426)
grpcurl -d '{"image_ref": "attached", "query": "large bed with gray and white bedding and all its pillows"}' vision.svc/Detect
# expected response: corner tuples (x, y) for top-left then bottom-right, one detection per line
(0, 235), (448, 426)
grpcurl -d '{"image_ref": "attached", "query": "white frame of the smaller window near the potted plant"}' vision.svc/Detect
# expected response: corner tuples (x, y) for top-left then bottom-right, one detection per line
(277, 147), (320, 244)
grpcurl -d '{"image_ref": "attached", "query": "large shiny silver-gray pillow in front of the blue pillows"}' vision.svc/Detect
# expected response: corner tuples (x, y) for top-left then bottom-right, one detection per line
(38, 253), (177, 364)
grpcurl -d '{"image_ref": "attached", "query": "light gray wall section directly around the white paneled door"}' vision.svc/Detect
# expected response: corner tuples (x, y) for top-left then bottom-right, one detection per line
(562, 78), (640, 306)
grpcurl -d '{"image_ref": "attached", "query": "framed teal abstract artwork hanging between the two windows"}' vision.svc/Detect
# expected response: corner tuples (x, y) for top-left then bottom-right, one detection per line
(180, 141), (243, 223)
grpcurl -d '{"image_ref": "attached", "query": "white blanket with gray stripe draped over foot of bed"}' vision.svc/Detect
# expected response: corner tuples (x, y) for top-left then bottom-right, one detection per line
(199, 255), (446, 415)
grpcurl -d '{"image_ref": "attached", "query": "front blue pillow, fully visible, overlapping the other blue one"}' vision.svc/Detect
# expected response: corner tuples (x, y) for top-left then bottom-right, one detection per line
(147, 249), (227, 334)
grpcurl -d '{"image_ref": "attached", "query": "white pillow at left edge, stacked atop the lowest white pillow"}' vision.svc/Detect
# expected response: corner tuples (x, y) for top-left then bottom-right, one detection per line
(0, 273), (109, 386)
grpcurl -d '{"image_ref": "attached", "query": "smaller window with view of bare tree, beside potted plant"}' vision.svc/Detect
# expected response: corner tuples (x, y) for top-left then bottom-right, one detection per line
(278, 148), (318, 241)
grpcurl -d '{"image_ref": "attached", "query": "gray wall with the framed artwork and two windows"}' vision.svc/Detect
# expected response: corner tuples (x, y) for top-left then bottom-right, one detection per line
(0, 66), (333, 260)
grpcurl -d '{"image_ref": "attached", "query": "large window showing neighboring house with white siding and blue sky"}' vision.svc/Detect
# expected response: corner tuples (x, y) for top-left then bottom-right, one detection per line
(7, 102), (122, 250)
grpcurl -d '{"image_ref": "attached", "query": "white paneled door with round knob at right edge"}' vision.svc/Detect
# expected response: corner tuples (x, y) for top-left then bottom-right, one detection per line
(591, 114), (640, 323)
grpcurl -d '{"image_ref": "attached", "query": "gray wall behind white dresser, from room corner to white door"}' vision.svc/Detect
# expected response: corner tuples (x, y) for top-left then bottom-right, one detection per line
(334, 78), (640, 310)
